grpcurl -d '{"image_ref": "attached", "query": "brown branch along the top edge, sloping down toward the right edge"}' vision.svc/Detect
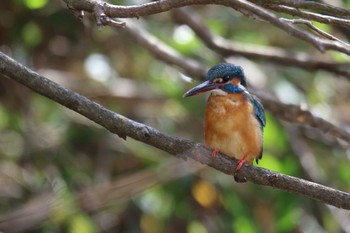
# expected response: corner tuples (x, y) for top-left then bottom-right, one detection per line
(64, 0), (350, 54)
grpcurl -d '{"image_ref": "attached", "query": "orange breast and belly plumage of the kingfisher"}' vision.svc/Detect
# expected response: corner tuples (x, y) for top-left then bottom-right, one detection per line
(204, 93), (263, 163)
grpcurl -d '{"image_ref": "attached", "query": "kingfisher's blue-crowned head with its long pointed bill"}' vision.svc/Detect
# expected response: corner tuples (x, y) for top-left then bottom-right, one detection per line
(184, 63), (247, 97)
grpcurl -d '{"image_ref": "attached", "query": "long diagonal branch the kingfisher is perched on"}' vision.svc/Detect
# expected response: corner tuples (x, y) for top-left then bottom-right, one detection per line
(0, 53), (350, 209)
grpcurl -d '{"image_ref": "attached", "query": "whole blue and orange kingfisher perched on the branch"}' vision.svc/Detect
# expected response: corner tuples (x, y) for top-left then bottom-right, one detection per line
(183, 63), (266, 182)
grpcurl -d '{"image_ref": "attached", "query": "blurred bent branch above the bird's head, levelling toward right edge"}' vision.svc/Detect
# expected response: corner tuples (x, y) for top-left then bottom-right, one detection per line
(172, 8), (350, 80)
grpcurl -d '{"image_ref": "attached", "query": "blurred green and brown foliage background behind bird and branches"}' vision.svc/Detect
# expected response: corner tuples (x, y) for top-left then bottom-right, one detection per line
(0, 0), (350, 233)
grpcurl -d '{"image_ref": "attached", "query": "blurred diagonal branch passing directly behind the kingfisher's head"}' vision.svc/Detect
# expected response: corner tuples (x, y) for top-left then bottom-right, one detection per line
(118, 20), (350, 143)
